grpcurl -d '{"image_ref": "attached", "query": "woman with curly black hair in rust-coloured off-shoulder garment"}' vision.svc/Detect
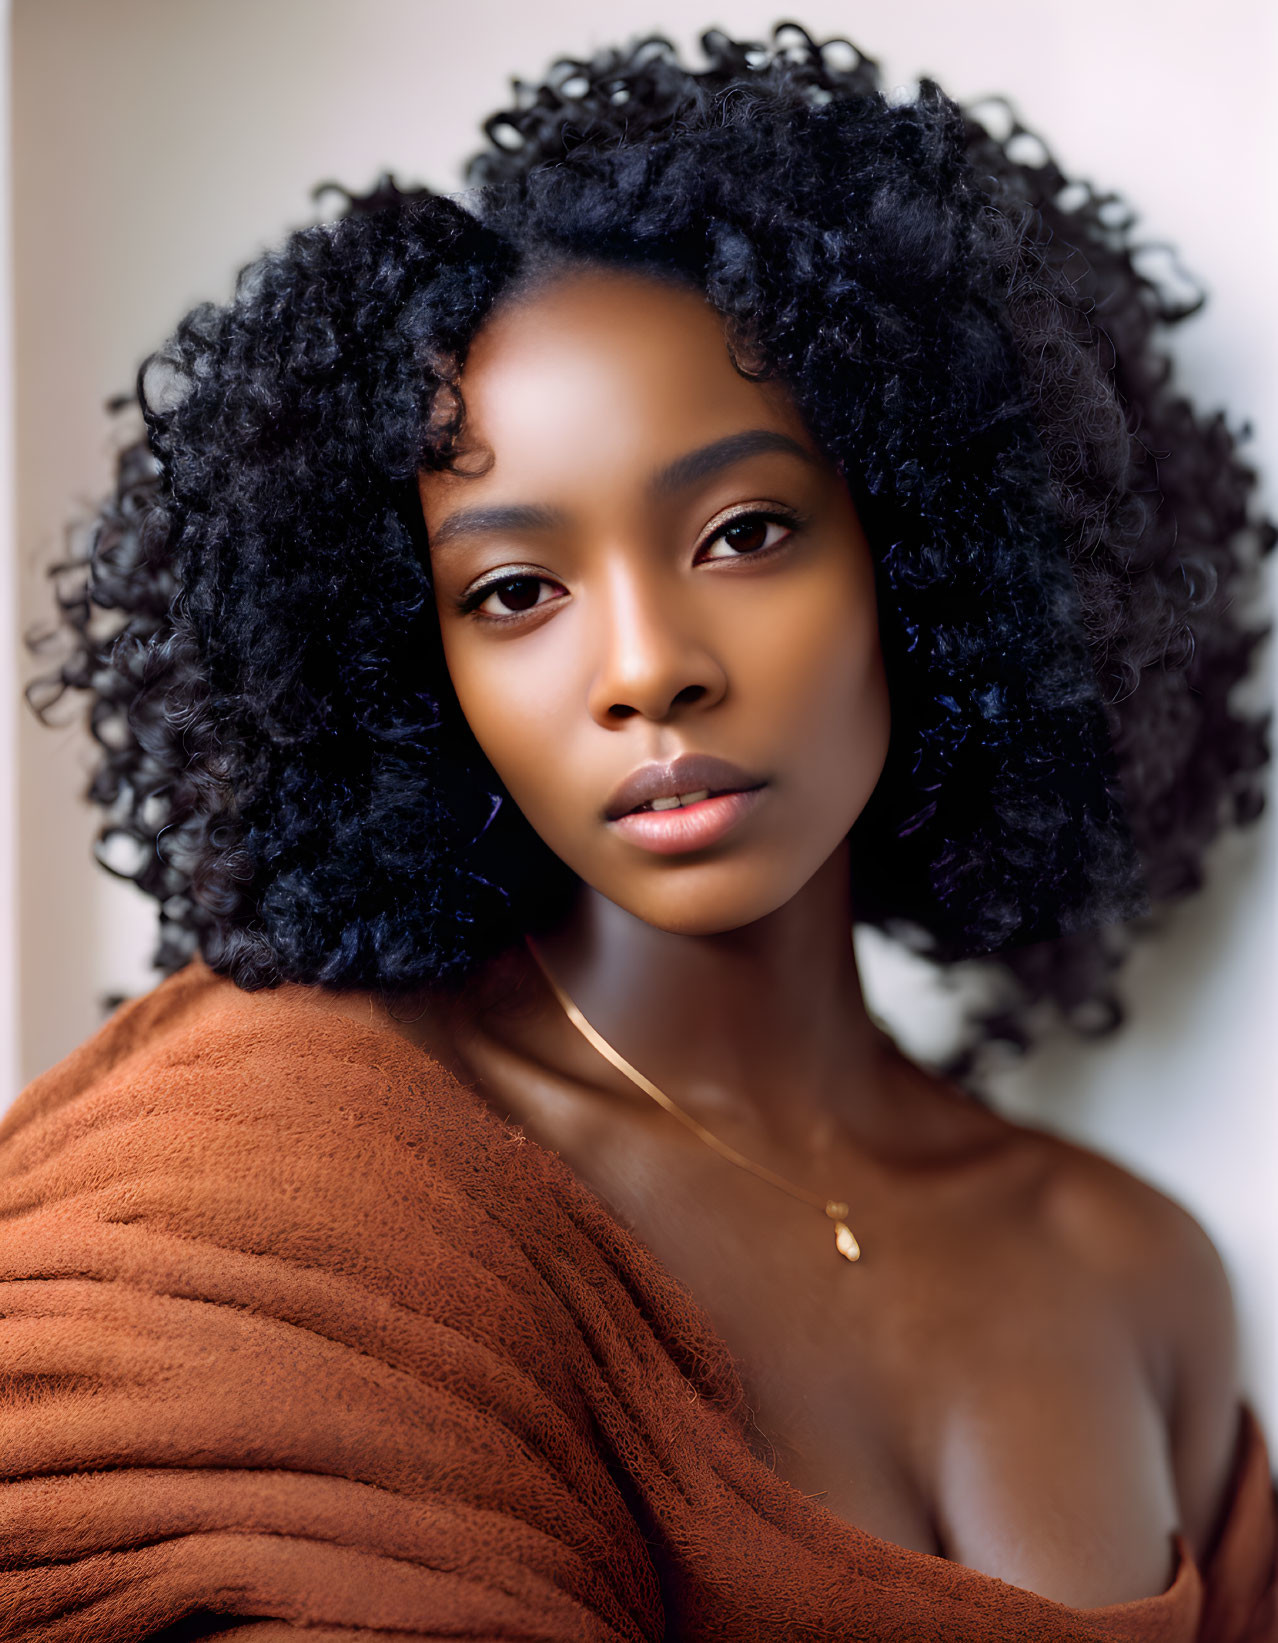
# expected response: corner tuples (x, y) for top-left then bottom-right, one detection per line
(0, 30), (1278, 1640)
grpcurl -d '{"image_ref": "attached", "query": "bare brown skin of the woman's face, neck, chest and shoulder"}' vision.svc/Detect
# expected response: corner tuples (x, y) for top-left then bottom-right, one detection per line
(402, 269), (1235, 1607)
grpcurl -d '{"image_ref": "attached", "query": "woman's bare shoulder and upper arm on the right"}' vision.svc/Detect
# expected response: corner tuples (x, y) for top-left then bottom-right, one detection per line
(1018, 1135), (1242, 1556)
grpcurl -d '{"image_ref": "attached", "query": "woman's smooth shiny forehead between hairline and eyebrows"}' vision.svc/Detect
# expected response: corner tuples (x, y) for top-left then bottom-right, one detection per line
(422, 269), (810, 519)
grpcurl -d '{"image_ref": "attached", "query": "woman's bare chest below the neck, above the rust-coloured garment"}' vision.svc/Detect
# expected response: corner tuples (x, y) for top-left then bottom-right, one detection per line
(542, 1104), (1178, 1607)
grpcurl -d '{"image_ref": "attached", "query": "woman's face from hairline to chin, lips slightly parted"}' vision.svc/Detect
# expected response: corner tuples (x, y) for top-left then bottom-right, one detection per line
(421, 269), (889, 935)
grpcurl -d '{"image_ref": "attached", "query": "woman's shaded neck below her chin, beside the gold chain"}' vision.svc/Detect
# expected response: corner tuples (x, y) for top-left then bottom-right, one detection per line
(537, 846), (885, 1153)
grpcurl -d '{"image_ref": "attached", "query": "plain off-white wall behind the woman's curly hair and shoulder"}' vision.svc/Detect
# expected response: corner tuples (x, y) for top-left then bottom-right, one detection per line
(9, 0), (1278, 1431)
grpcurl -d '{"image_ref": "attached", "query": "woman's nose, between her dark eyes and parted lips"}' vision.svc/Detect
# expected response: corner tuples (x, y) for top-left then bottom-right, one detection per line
(590, 572), (728, 729)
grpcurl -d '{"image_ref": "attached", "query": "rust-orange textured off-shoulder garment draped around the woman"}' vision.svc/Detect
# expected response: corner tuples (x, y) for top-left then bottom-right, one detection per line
(0, 963), (1278, 1643)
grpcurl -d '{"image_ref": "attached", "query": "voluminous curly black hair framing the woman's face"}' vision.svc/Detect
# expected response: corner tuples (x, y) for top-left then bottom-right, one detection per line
(31, 25), (1278, 1073)
